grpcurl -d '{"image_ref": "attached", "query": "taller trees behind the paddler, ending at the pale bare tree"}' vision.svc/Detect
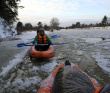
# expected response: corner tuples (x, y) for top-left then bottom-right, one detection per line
(16, 17), (60, 34)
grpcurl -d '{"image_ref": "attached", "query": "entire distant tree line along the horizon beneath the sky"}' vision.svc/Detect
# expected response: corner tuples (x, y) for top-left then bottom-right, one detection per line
(16, 15), (110, 33)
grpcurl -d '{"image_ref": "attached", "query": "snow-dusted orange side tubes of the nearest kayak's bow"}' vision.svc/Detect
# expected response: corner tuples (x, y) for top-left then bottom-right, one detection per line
(38, 63), (101, 93)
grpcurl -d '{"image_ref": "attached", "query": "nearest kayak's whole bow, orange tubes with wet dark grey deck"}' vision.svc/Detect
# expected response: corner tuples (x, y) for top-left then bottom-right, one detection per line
(37, 61), (104, 93)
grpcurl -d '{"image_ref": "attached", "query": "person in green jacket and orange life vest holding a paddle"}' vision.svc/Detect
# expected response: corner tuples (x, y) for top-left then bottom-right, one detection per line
(34, 28), (54, 51)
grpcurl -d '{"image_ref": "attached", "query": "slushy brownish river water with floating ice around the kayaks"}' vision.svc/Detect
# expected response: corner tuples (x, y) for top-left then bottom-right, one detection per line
(0, 29), (110, 93)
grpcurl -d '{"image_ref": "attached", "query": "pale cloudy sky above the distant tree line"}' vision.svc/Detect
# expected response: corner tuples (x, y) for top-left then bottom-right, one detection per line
(18, 0), (110, 26)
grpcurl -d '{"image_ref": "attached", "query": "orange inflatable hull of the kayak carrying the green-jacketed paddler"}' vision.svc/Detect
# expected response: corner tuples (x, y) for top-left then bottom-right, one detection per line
(30, 45), (55, 59)
